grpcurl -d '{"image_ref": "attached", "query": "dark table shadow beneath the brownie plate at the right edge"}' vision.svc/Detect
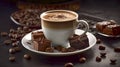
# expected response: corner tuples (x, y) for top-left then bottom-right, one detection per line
(96, 35), (120, 48)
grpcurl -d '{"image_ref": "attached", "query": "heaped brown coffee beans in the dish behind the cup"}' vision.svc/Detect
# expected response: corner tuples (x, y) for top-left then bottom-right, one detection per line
(12, 9), (41, 27)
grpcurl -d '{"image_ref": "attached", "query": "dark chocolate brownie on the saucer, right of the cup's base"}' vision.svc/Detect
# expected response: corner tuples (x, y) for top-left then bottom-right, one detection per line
(69, 34), (89, 49)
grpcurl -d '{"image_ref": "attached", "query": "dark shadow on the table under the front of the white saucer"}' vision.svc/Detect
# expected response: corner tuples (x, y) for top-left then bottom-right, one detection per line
(29, 49), (94, 65)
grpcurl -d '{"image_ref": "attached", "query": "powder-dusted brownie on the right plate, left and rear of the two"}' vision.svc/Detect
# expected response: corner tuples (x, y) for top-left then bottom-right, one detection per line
(96, 21), (115, 32)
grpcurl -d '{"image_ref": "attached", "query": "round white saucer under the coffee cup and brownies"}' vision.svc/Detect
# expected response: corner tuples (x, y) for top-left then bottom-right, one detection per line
(21, 29), (96, 56)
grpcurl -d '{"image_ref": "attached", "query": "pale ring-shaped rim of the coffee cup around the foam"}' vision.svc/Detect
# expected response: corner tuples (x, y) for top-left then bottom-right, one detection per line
(40, 10), (78, 22)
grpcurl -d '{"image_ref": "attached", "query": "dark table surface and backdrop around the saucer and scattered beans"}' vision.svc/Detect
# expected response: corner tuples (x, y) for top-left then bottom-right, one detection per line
(0, 0), (120, 67)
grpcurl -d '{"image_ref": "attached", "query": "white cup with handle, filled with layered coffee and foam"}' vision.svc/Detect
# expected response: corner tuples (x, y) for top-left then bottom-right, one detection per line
(40, 10), (89, 47)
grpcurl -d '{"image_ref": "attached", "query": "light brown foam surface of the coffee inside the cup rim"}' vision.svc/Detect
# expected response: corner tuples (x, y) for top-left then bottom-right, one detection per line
(44, 11), (76, 21)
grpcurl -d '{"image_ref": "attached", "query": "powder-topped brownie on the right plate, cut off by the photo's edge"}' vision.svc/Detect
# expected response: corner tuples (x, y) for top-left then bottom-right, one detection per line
(103, 24), (120, 35)
